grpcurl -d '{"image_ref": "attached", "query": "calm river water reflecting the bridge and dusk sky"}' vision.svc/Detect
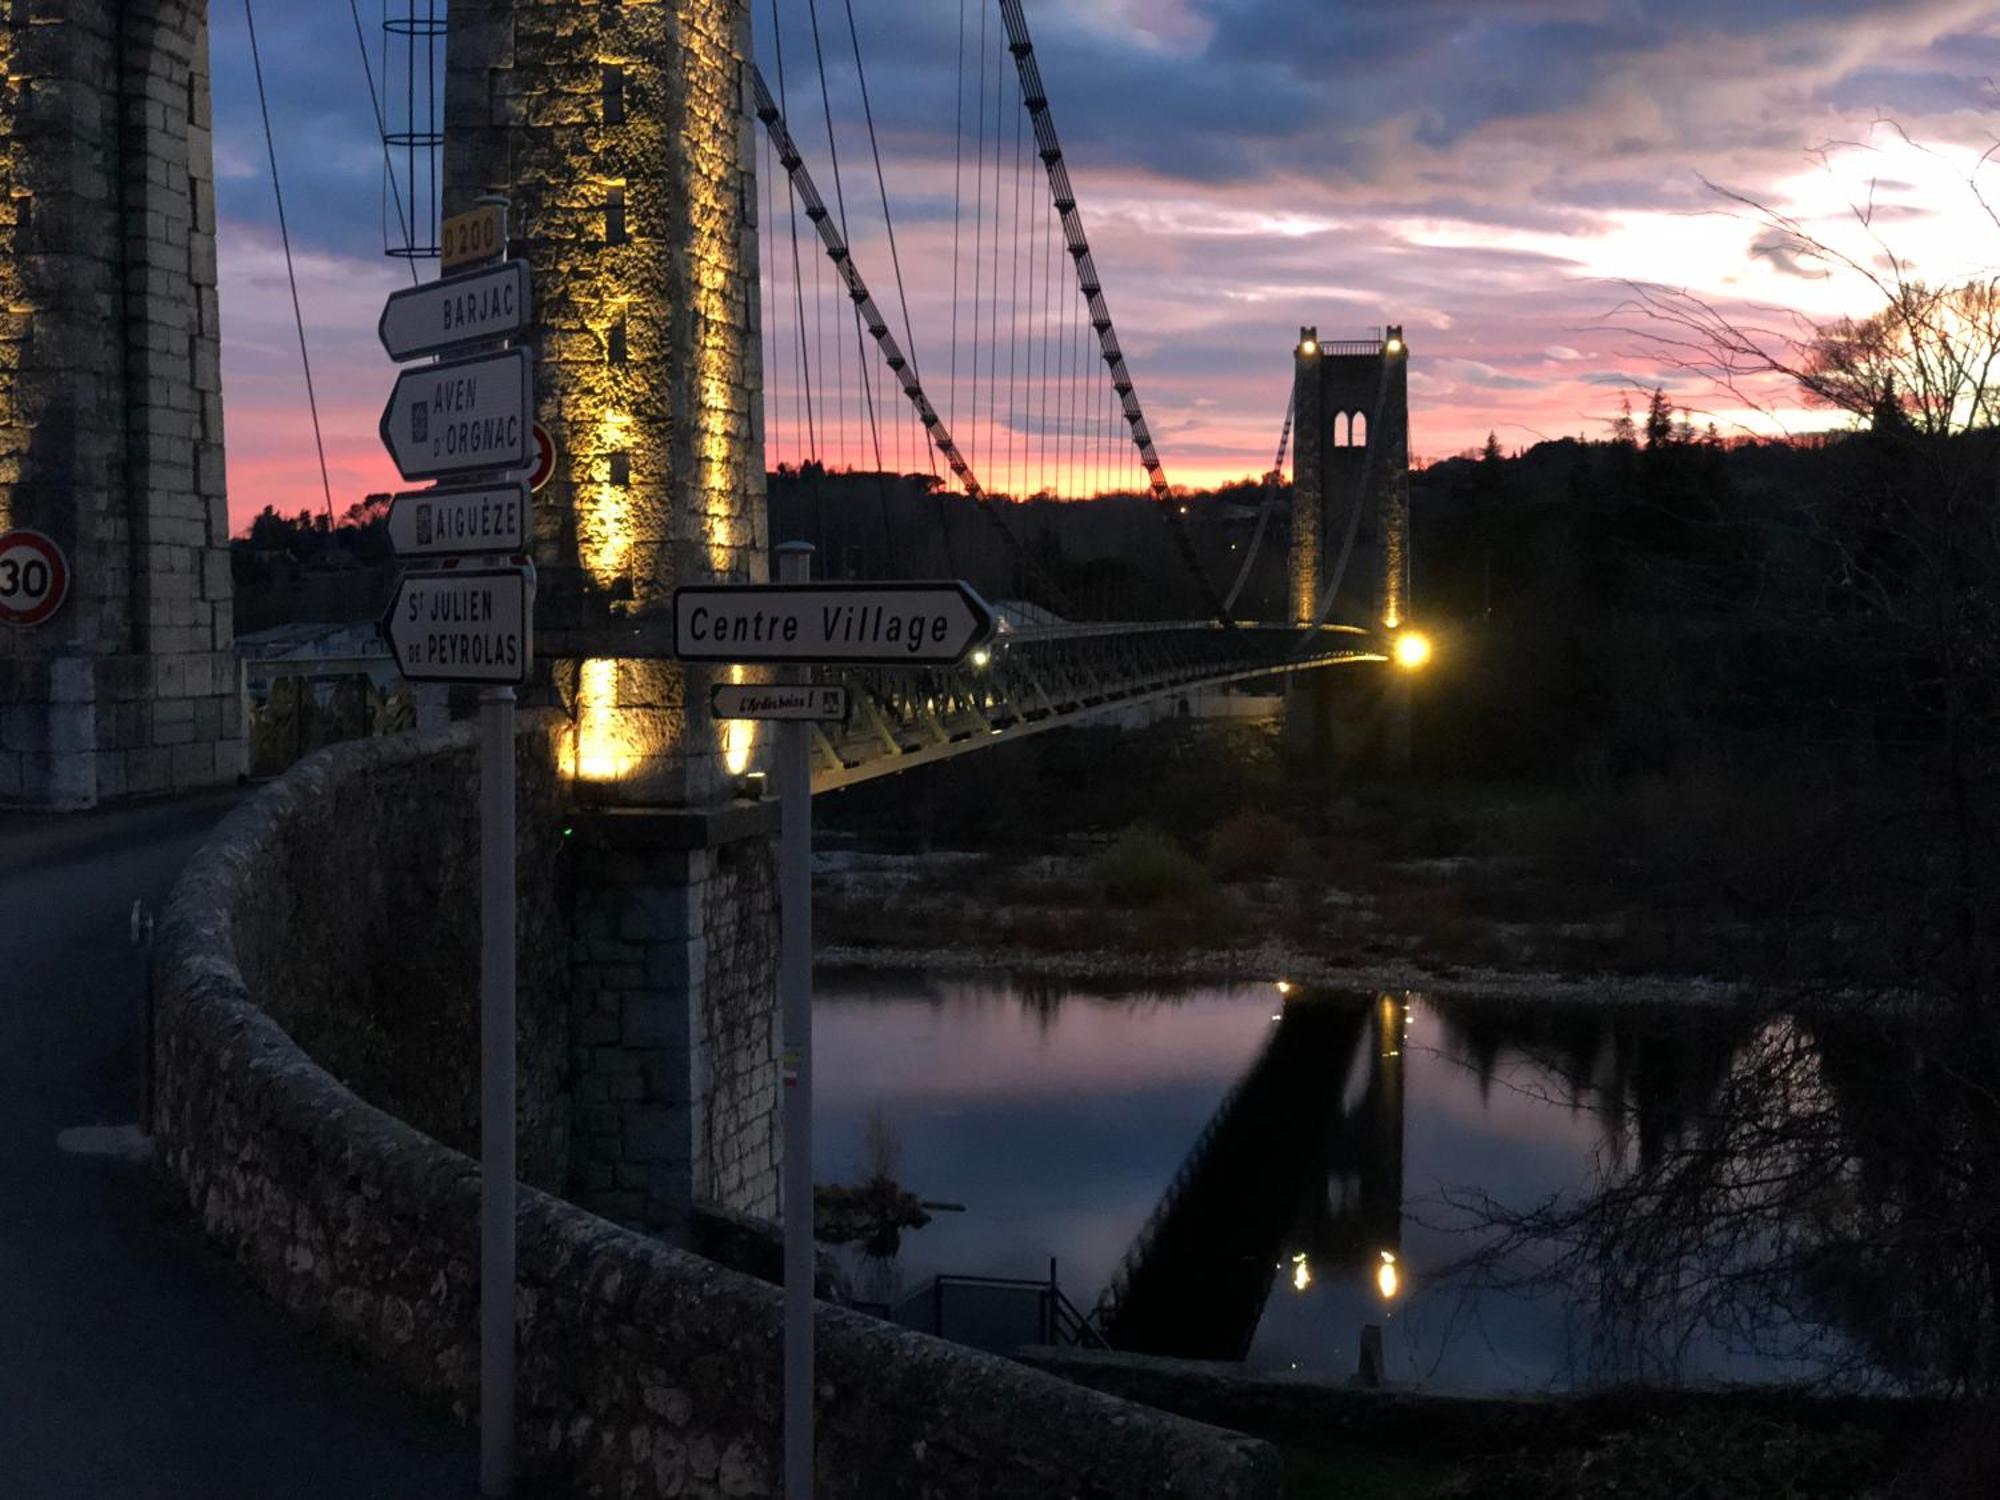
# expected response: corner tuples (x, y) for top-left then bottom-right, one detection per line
(814, 972), (1888, 1390)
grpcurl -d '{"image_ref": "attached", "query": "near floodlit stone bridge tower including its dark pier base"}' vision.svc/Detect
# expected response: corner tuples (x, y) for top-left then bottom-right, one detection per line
(444, 0), (778, 1232)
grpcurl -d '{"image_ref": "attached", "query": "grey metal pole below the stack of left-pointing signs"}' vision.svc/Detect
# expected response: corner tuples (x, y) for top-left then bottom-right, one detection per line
(480, 688), (514, 1496)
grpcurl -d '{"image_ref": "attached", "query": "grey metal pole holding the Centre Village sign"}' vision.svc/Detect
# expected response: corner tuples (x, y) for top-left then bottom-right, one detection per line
(778, 542), (812, 1500)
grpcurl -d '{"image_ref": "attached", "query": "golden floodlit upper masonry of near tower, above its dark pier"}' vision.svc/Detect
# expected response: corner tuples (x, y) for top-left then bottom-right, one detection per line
(444, 0), (768, 806)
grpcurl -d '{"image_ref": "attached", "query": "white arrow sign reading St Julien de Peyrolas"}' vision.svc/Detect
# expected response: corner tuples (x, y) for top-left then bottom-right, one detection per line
(382, 566), (534, 684)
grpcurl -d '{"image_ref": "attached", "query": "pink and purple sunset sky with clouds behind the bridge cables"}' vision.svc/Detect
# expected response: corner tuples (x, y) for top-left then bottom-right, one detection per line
(212, 0), (2000, 526)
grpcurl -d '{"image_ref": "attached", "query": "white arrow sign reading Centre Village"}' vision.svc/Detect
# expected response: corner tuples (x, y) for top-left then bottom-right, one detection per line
(674, 580), (994, 666)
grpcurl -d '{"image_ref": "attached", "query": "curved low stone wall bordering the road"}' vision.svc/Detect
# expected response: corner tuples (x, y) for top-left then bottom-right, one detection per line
(154, 722), (1276, 1500)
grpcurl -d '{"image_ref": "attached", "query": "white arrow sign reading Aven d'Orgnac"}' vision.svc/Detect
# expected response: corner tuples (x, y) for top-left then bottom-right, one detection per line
(382, 348), (534, 480)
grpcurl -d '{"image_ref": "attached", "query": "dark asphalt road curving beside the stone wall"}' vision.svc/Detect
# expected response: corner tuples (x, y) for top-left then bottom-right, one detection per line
(0, 796), (478, 1500)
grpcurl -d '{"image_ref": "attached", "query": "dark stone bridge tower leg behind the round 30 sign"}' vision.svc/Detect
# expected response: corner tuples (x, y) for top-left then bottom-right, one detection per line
(0, 0), (244, 808)
